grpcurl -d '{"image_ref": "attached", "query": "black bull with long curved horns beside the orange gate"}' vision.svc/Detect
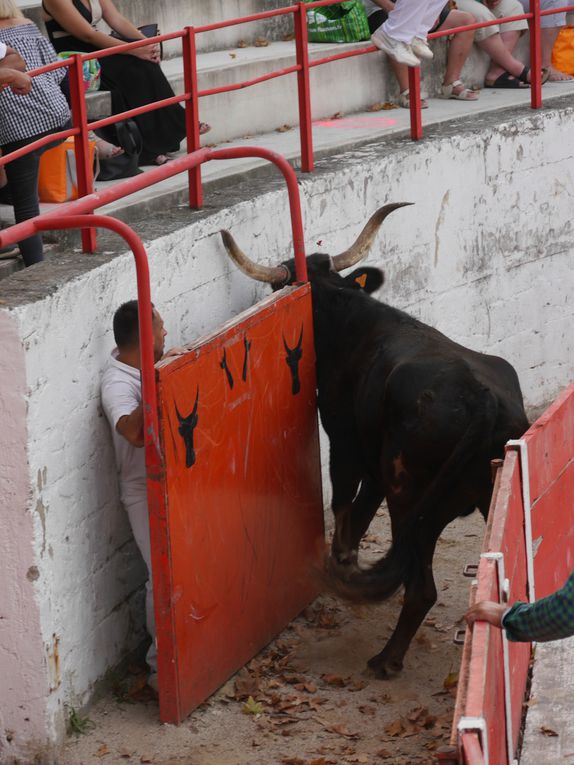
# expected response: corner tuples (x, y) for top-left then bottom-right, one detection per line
(222, 204), (528, 677)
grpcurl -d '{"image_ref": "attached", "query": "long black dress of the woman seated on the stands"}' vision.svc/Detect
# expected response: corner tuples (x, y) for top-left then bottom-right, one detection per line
(44, 0), (185, 164)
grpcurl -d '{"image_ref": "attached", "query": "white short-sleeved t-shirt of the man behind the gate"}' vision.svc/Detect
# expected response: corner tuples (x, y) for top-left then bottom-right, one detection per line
(102, 348), (147, 506)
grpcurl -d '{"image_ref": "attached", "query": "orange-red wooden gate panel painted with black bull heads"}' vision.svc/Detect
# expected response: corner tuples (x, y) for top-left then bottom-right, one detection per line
(150, 284), (323, 722)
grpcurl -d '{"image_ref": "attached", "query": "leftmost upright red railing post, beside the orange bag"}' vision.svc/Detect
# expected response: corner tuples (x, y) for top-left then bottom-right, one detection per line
(68, 53), (96, 252)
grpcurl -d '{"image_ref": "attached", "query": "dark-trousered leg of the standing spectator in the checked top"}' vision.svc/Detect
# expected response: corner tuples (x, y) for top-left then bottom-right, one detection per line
(6, 152), (44, 266)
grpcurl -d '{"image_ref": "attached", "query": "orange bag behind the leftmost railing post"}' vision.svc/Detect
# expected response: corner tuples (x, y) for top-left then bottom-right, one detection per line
(38, 138), (96, 202)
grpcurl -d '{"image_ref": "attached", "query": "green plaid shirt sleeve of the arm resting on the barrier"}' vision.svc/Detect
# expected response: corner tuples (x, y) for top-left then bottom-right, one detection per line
(502, 571), (574, 642)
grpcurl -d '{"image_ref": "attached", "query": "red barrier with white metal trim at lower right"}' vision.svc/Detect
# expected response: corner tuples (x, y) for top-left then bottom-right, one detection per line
(452, 384), (574, 765)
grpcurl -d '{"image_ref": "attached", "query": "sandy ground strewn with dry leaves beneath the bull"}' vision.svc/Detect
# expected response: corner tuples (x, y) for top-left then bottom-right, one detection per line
(58, 511), (484, 765)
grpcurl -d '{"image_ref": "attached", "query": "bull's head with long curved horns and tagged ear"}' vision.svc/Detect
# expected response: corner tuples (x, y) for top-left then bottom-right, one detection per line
(221, 202), (411, 292)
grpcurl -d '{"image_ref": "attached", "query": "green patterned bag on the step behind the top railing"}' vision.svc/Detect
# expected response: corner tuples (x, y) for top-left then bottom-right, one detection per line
(304, 0), (371, 42)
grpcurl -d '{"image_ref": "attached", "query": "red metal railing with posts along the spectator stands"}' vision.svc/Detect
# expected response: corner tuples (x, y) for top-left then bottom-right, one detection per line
(0, 0), (574, 252)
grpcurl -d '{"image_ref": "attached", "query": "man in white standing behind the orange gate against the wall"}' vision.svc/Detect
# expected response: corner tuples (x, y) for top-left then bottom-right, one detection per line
(101, 300), (183, 690)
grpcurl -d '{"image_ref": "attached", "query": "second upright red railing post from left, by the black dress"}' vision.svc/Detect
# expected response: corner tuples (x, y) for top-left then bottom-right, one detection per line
(183, 27), (203, 210)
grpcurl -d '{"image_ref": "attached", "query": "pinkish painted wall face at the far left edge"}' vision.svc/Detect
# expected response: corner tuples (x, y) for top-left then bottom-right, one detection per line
(0, 312), (51, 763)
